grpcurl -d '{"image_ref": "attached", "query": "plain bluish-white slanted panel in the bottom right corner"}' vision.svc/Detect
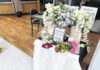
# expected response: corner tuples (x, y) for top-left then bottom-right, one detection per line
(88, 40), (100, 70)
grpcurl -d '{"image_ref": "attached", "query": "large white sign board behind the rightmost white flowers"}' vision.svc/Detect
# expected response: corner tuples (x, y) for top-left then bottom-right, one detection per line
(81, 6), (98, 28)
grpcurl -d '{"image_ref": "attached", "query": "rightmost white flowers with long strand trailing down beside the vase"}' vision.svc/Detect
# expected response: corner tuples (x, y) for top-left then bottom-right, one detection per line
(75, 10), (91, 41)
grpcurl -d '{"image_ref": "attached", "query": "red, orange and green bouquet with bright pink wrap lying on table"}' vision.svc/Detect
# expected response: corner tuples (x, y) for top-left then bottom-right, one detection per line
(55, 41), (78, 53)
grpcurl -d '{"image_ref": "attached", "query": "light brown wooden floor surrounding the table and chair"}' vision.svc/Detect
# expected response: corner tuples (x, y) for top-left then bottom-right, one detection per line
(0, 15), (100, 69)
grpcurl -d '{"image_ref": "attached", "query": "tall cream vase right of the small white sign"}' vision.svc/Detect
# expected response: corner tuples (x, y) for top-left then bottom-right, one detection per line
(69, 26), (82, 44)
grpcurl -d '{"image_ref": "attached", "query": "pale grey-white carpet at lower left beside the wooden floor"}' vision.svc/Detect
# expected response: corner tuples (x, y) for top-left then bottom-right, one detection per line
(0, 38), (33, 70)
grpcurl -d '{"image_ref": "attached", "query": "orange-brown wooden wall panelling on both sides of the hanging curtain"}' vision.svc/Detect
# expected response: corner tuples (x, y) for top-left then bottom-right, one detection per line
(0, 1), (40, 14)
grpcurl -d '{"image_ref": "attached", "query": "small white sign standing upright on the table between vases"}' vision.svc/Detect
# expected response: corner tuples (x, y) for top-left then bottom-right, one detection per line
(53, 27), (66, 41)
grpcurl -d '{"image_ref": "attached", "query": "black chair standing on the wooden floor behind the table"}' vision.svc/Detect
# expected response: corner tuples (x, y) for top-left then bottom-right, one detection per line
(30, 9), (41, 36)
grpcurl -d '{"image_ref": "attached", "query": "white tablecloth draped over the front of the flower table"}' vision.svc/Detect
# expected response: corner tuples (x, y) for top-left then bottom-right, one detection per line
(33, 39), (81, 70)
